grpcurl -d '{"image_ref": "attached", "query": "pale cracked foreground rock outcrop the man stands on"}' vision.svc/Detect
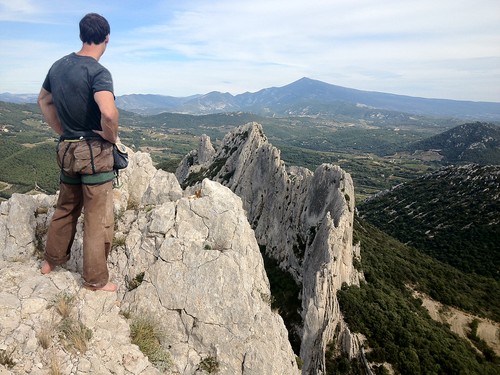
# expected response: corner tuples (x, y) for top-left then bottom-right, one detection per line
(0, 153), (299, 375)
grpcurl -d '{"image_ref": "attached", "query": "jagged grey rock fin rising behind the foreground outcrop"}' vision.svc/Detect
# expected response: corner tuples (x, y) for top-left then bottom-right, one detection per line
(176, 123), (363, 374)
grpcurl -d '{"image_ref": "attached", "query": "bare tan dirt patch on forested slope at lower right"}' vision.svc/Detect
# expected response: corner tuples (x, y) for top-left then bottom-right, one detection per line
(414, 292), (500, 355)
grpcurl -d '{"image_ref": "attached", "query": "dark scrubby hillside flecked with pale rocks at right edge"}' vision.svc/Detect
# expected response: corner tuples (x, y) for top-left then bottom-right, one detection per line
(359, 164), (500, 280)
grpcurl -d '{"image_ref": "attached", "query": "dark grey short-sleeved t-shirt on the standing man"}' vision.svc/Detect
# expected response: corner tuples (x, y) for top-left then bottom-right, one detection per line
(42, 53), (113, 139)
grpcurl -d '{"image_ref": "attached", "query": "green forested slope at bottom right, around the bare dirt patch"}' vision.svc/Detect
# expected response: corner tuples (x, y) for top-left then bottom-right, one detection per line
(327, 219), (500, 374)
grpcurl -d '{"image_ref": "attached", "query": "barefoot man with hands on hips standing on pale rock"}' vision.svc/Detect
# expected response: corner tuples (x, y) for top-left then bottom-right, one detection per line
(38, 13), (118, 292)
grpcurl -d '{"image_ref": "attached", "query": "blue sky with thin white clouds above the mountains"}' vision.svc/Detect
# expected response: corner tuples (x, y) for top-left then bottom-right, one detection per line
(0, 0), (500, 102)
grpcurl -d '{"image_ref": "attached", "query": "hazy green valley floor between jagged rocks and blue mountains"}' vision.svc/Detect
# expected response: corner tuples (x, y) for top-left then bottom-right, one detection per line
(0, 102), (446, 200)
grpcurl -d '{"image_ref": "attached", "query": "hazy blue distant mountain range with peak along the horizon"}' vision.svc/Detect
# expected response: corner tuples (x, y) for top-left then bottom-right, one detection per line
(0, 78), (500, 121)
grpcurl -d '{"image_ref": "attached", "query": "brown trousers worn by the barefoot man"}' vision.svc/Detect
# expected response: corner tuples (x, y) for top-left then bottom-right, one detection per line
(45, 141), (114, 288)
